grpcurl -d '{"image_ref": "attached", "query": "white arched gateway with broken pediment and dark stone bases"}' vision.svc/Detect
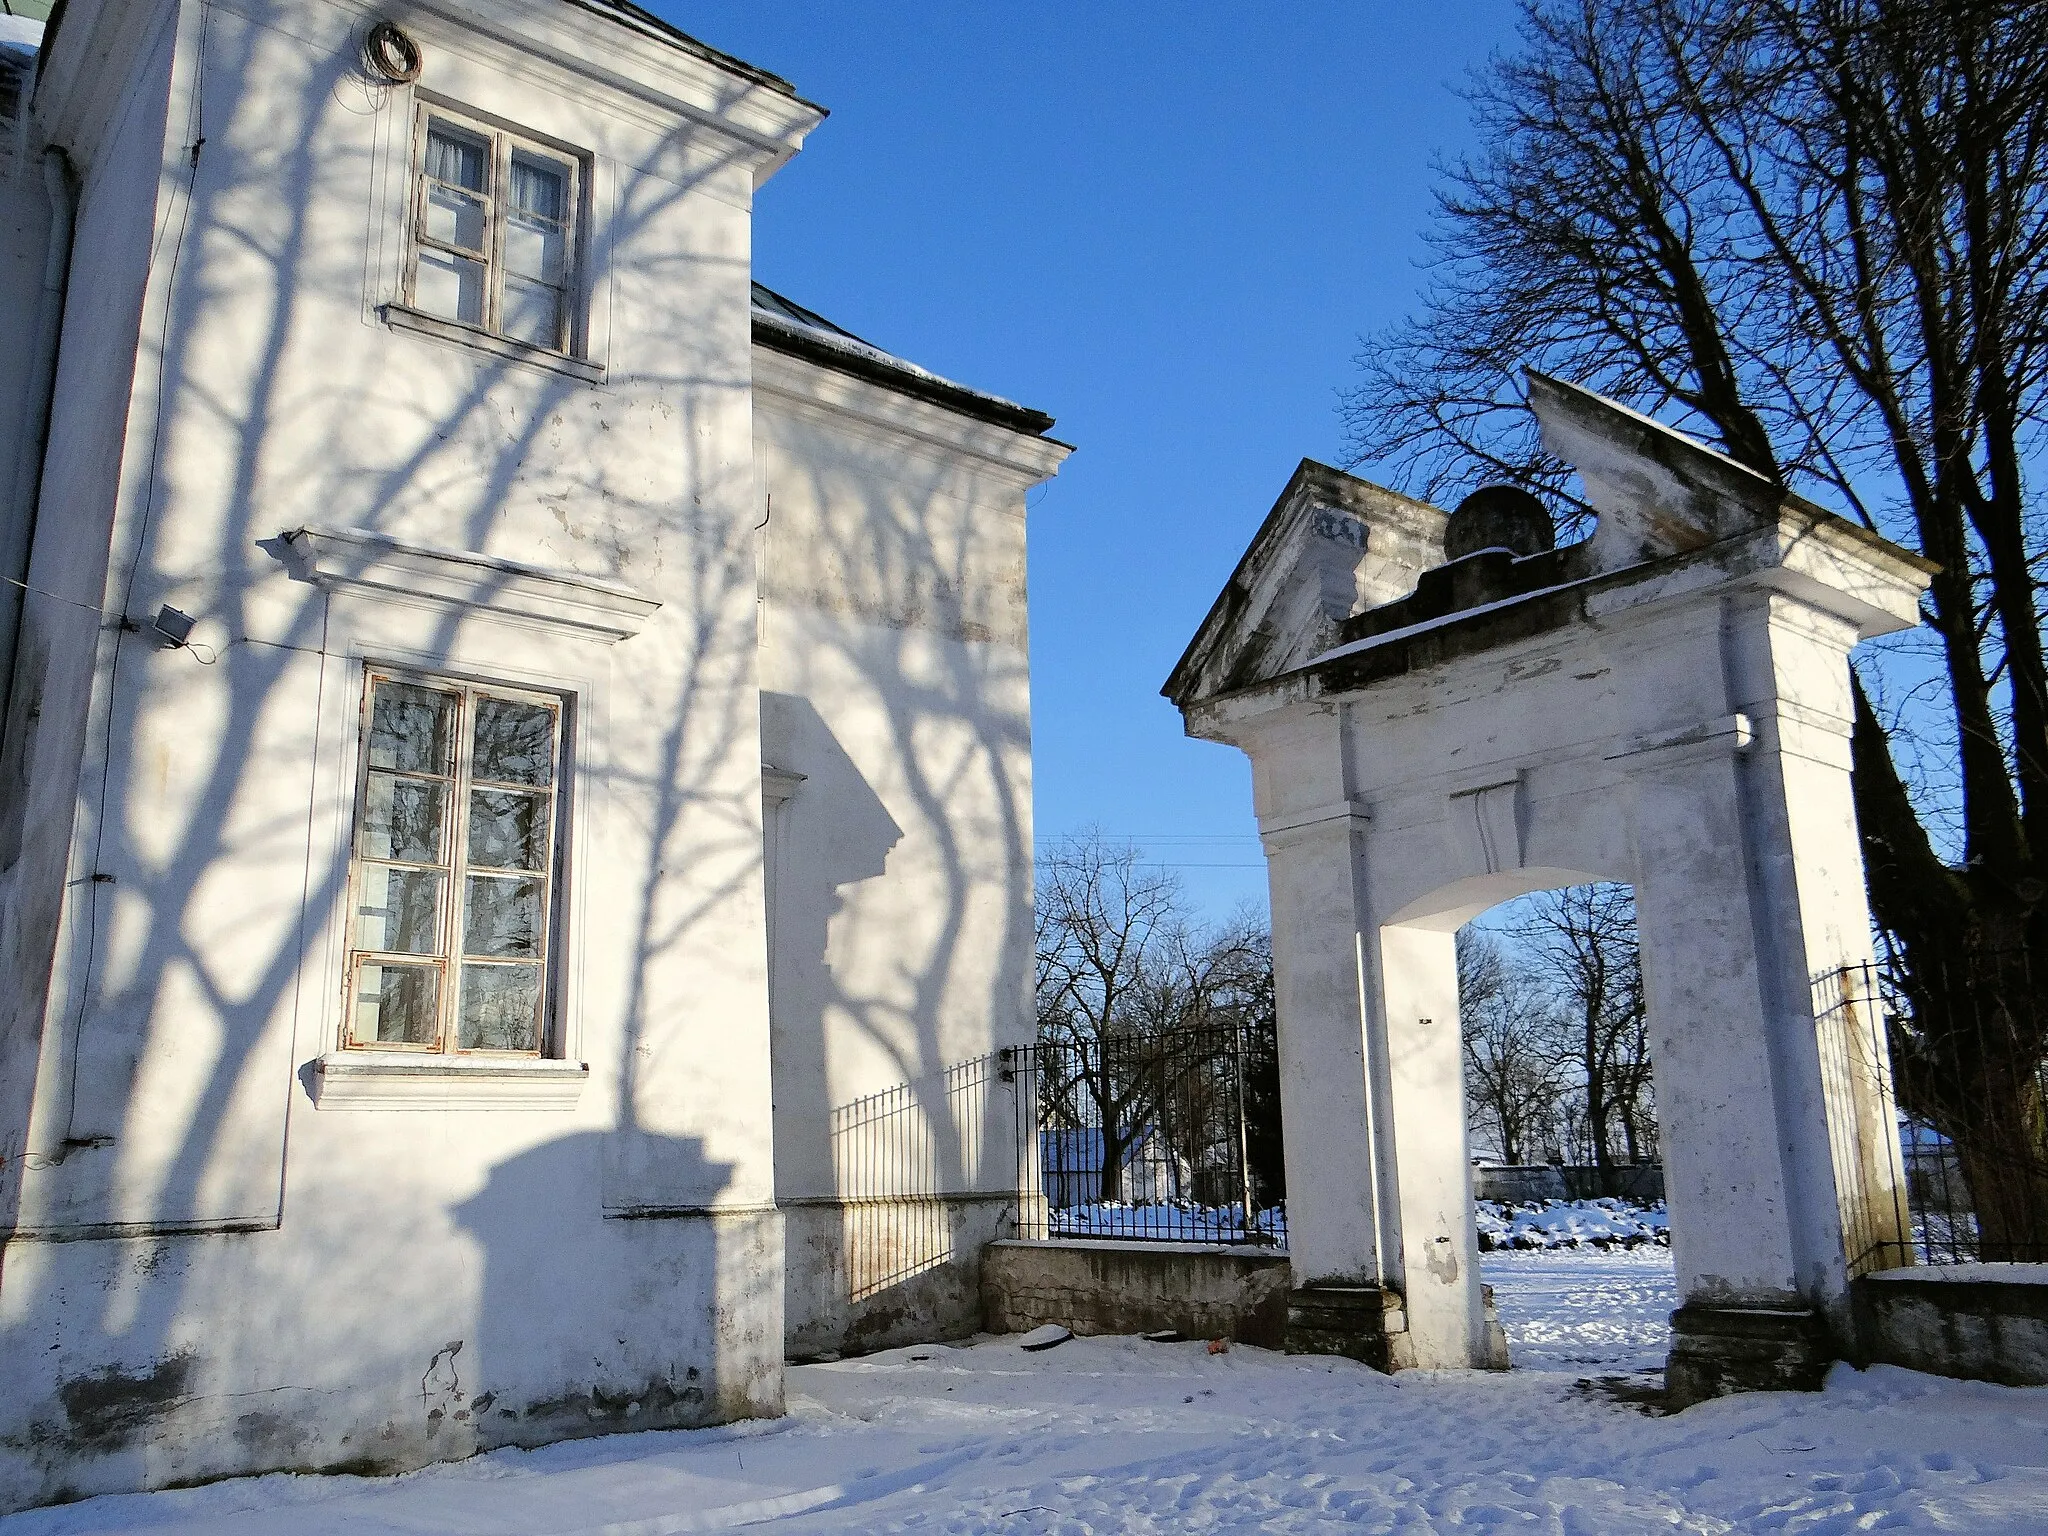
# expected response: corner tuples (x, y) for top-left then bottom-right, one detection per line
(1165, 375), (1931, 1403)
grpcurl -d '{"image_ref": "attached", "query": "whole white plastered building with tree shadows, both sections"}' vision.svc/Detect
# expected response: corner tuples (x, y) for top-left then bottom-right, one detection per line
(0, 0), (1067, 1509)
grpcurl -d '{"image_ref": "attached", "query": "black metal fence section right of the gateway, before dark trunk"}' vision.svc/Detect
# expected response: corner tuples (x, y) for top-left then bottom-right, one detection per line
(1815, 952), (2048, 1274)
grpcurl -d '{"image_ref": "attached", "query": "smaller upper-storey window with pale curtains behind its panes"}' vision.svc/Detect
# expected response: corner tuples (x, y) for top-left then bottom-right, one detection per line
(408, 109), (578, 352)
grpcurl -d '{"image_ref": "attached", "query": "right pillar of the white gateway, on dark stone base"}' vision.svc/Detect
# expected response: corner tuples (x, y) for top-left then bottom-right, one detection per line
(1614, 592), (1901, 1403)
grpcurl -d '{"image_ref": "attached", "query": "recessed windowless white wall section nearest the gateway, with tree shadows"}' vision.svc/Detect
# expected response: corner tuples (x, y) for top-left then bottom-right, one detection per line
(754, 348), (1065, 1356)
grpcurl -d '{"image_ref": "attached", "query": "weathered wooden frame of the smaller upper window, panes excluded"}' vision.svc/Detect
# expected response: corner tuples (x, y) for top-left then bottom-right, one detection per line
(403, 98), (590, 358)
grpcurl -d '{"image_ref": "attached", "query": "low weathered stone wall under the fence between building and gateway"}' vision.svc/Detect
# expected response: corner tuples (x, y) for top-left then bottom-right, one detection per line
(981, 1239), (1290, 1350)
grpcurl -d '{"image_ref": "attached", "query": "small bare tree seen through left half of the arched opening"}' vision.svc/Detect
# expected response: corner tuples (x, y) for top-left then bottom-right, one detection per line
(1458, 928), (1571, 1163)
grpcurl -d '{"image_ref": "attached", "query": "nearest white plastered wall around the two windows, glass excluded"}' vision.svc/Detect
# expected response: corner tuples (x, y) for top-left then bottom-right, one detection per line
(0, 0), (815, 1507)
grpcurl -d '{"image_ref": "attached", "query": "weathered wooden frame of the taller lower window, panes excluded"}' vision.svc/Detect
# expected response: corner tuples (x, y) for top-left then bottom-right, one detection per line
(340, 662), (575, 1063)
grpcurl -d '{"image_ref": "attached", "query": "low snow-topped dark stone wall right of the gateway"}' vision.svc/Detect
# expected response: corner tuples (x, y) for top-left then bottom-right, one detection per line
(1851, 1264), (2048, 1386)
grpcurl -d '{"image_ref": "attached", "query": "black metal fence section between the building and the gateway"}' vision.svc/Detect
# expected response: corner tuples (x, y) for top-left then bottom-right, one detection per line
(1001, 1026), (1286, 1245)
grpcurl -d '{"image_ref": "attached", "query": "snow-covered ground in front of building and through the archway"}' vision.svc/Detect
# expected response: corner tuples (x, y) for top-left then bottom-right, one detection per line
(0, 1249), (2048, 1536)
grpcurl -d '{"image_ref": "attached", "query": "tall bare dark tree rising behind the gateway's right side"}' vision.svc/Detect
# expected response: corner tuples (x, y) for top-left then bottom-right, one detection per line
(1348, 0), (2048, 1251)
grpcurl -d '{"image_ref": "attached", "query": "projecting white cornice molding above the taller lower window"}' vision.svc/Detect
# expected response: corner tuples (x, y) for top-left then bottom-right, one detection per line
(283, 526), (662, 643)
